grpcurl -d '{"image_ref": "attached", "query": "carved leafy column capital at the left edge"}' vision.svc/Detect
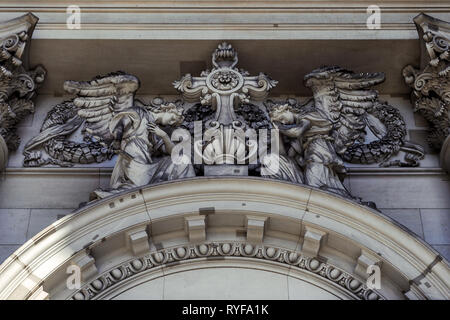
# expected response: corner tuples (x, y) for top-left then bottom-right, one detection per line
(0, 13), (46, 170)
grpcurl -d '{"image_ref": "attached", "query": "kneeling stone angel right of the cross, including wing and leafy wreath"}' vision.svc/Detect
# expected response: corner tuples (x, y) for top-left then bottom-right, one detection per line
(266, 67), (424, 197)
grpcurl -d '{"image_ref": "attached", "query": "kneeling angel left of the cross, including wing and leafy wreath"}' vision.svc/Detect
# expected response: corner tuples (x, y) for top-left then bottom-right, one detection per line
(24, 72), (194, 198)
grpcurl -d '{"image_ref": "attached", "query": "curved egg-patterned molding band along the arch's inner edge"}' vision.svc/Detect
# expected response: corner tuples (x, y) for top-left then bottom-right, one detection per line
(70, 242), (384, 300)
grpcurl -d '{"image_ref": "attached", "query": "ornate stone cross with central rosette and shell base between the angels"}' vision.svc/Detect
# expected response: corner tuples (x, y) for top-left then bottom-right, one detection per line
(173, 42), (278, 175)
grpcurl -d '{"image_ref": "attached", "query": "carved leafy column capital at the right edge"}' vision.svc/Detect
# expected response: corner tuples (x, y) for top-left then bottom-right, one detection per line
(403, 13), (450, 170)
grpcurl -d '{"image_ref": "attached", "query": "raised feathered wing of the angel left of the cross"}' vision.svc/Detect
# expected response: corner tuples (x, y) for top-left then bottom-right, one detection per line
(64, 71), (140, 141)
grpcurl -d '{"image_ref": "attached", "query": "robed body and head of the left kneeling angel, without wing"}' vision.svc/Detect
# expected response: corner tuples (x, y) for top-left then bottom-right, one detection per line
(94, 103), (195, 198)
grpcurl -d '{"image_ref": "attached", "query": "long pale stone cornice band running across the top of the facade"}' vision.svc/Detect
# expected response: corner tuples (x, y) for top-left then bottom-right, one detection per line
(0, 1), (450, 40)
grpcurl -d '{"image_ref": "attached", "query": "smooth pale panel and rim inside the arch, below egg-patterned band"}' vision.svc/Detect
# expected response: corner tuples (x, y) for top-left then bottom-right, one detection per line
(95, 256), (357, 300)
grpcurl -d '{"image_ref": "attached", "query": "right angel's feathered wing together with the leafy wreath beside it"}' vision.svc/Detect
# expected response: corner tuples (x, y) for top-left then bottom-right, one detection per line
(305, 66), (425, 166)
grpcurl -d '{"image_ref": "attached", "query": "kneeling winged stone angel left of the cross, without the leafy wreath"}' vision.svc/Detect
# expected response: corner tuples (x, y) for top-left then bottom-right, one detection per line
(26, 72), (195, 200)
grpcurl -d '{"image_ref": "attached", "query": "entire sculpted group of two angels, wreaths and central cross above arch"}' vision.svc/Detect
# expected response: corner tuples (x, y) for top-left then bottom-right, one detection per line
(24, 43), (424, 201)
